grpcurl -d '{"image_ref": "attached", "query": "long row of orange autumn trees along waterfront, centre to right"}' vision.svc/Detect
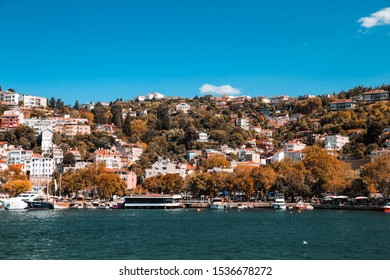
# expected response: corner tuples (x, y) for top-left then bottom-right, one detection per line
(140, 147), (362, 200)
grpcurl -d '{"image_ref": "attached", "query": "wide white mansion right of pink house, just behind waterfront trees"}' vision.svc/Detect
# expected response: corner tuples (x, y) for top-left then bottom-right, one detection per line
(145, 159), (187, 179)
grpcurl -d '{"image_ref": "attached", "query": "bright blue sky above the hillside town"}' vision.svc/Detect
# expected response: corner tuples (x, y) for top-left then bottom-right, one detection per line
(0, 0), (390, 104)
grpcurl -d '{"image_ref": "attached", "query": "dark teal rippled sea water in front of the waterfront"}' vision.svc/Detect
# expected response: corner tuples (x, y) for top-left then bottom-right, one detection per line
(0, 209), (390, 260)
